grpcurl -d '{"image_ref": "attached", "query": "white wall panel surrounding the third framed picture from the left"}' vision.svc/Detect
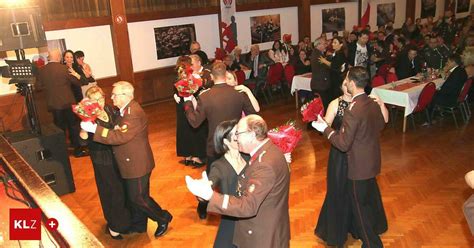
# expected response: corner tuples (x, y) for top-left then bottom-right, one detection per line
(311, 2), (358, 40)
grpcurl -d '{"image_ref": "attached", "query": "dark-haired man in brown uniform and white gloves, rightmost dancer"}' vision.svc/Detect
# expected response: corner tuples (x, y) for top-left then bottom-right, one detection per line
(313, 66), (387, 247)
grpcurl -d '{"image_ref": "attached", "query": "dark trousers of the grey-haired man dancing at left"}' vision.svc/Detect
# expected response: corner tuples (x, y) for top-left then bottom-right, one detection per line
(125, 173), (172, 231)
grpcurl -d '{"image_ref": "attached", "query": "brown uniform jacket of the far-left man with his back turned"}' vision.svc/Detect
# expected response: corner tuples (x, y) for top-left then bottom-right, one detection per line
(38, 62), (82, 110)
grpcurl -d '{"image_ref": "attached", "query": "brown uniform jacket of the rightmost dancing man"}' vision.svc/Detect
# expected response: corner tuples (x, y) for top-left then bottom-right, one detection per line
(324, 94), (385, 180)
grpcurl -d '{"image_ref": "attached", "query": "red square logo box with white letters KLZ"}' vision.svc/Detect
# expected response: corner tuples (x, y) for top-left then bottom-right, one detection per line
(10, 208), (41, 240)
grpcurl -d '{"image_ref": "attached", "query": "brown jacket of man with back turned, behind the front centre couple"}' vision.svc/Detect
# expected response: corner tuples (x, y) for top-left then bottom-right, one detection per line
(184, 83), (256, 156)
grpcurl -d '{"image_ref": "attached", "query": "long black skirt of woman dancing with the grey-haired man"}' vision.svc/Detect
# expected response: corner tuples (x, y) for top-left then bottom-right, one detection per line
(90, 149), (131, 233)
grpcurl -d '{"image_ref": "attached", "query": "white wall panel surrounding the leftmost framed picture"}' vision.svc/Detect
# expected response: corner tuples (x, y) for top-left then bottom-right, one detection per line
(128, 15), (220, 72)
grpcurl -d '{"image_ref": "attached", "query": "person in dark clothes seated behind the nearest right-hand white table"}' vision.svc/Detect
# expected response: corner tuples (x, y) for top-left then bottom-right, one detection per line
(395, 46), (421, 79)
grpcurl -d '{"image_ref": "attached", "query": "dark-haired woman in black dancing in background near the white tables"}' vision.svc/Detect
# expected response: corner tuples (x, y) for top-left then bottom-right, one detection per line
(320, 37), (348, 100)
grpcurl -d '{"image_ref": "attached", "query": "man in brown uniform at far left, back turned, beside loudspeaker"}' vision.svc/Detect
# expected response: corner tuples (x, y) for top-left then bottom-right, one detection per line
(38, 50), (88, 157)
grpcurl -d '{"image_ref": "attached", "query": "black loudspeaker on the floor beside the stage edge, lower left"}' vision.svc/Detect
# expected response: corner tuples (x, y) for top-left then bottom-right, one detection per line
(4, 124), (76, 195)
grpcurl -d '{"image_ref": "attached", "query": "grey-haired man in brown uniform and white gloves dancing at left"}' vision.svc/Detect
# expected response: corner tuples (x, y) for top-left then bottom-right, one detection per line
(81, 81), (173, 237)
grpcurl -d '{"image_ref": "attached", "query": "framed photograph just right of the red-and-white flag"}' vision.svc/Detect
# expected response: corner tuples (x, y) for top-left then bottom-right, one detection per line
(250, 14), (281, 44)
